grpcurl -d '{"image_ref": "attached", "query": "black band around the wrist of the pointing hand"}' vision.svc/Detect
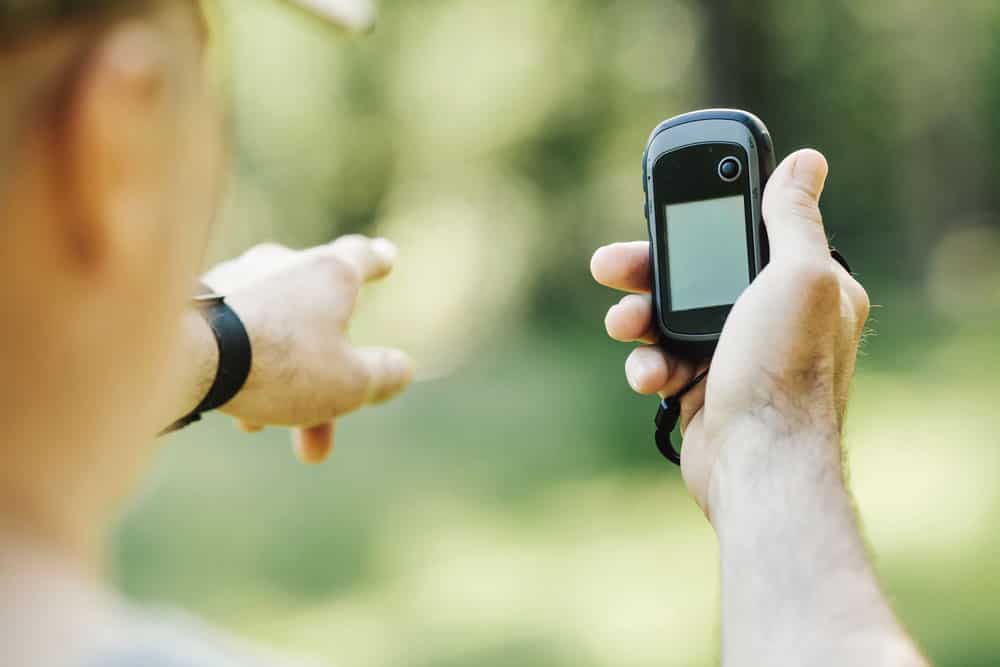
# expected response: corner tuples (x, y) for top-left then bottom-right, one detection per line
(165, 294), (253, 433)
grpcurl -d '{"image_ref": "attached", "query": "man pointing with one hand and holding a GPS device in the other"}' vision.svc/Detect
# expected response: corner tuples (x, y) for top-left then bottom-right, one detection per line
(0, 0), (922, 667)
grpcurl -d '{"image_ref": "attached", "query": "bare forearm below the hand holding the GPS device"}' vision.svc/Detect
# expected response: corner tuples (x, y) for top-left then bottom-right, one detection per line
(712, 428), (926, 667)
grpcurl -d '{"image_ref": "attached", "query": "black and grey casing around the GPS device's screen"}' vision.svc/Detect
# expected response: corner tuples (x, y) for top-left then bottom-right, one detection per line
(642, 109), (776, 359)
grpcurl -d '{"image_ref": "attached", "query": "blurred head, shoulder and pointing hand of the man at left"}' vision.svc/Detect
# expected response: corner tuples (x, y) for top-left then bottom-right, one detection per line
(0, 0), (412, 667)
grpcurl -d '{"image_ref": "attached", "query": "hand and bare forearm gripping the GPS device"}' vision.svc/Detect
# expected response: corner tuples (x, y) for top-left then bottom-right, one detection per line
(591, 150), (926, 667)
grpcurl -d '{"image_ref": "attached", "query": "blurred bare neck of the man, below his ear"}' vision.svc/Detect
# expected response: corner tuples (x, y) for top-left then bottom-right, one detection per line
(0, 354), (149, 578)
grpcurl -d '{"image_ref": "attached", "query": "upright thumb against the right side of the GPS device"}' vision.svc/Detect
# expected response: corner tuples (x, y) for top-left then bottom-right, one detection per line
(762, 148), (830, 261)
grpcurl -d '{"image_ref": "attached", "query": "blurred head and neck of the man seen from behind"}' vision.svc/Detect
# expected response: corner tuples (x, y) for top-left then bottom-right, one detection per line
(0, 0), (372, 560)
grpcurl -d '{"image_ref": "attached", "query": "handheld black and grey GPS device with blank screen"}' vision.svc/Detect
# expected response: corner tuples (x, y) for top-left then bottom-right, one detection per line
(642, 109), (775, 358)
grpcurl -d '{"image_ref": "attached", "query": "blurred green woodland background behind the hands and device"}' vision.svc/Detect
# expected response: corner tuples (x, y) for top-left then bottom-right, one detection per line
(116, 0), (1000, 667)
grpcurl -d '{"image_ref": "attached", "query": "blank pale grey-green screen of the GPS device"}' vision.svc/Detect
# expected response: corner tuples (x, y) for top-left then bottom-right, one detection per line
(666, 195), (750, 311)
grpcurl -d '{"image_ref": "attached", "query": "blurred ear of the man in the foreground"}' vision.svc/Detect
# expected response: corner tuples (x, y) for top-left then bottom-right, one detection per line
(61, 19), (177, 268)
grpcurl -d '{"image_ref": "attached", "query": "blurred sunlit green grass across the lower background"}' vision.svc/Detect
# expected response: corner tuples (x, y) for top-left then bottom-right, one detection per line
(118, 312), (1000, 667)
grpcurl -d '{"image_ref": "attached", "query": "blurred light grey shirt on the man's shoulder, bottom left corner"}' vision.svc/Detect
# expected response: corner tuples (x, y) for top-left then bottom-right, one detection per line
(0, 531), (316, 667)
